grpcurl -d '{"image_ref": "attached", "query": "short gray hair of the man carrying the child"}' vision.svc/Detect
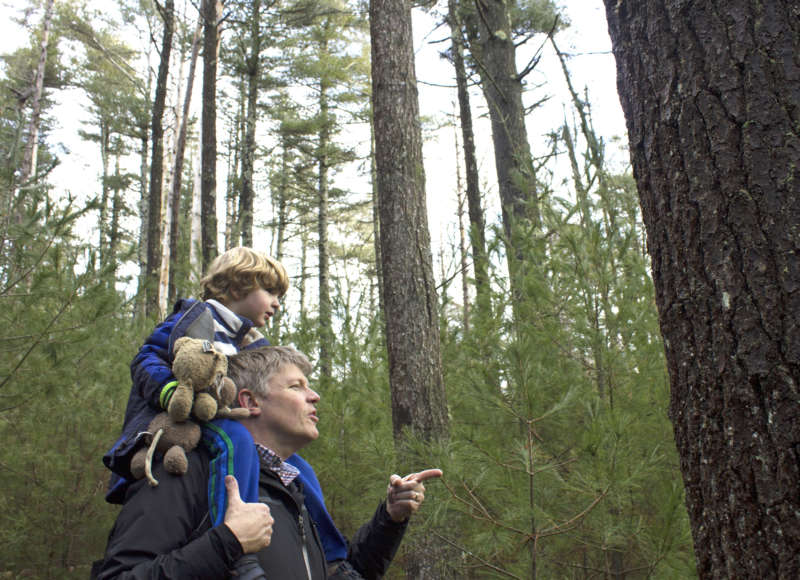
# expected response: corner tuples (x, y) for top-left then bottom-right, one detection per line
(228, 346), (314, 397)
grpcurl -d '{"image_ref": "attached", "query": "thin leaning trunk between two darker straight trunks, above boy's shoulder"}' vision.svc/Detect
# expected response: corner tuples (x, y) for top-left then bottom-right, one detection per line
(167, 19), (203, 304)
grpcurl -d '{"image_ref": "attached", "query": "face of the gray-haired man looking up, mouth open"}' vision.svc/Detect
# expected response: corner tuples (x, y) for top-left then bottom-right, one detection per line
(256, 364), (320, 459)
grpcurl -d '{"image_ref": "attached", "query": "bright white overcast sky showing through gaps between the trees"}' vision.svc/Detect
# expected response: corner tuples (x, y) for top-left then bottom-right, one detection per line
(0, 0), (627, 268)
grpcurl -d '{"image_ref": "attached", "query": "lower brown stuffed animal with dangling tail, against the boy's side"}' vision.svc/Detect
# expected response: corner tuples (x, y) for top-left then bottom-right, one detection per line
(131, 412), (201, 487)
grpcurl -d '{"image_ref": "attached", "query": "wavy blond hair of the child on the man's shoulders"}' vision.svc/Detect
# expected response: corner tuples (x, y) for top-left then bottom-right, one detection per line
(200, 247), (289, 304)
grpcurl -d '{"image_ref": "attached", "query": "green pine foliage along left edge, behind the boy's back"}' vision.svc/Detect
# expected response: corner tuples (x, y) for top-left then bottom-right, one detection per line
(0, 185), (136, 578)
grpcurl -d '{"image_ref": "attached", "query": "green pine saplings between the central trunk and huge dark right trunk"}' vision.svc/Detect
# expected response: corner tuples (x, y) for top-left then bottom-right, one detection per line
(422, 135), (695, 578)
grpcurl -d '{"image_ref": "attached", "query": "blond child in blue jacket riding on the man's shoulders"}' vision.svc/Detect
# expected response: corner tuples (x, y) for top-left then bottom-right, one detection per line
(103, 247), (347, 562)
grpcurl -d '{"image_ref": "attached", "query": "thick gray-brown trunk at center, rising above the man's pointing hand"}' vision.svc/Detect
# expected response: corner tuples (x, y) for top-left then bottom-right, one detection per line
(370, 0), (448, 441)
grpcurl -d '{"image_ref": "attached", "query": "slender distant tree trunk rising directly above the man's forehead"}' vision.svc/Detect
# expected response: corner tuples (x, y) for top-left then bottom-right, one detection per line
(317, 72), (333, 389)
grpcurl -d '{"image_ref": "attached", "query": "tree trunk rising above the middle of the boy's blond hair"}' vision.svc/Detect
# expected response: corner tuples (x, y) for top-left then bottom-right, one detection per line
(239, 0), (261, 247)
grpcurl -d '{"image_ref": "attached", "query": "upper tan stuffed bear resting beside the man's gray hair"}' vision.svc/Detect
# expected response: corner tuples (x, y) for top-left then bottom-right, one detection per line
(167, 336), (250, 421)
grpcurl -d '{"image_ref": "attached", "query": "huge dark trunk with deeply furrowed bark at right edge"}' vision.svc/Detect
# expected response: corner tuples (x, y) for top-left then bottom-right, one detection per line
(605, 0), (800, 578)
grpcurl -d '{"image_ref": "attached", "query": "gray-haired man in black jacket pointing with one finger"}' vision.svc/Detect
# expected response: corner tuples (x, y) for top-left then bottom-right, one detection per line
(98, 346), (442, 580)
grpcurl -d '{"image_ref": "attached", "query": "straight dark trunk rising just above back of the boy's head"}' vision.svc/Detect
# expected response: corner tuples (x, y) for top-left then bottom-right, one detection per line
(200, 0), (222, 271)
